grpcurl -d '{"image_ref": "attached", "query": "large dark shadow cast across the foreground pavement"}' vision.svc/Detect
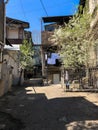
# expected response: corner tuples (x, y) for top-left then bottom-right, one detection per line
(0, 88), (98, 130)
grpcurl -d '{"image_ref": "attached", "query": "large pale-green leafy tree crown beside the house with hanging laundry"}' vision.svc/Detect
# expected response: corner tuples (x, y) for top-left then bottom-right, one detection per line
(51, 7), (94, 68)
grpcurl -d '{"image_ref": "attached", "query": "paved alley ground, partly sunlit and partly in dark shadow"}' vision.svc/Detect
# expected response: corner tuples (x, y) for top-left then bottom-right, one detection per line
(0, 80), (98, 130)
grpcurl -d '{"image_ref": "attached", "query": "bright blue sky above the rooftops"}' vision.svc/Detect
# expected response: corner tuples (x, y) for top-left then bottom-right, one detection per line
(6, 0), (79, 43)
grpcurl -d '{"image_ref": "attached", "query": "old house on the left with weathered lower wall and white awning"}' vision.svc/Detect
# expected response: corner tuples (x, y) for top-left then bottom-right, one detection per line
(0, 15), (31, 96)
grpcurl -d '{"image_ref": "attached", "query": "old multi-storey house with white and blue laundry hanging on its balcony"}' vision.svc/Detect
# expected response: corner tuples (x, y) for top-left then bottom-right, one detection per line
(41, 16), (72, 84)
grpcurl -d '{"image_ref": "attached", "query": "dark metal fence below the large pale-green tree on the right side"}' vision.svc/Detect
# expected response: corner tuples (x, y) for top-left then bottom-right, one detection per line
(65, 67), (98, 90)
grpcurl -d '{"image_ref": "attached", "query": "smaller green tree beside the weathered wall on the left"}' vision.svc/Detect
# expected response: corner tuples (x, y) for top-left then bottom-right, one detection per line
(20, 40), (34, 70)
